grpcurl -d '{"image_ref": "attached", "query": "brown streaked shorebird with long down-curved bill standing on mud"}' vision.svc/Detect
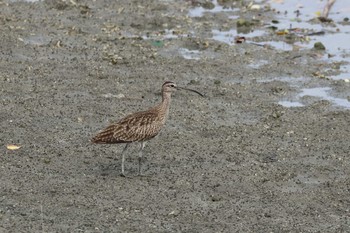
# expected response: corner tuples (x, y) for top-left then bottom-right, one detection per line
(91, 81), (203, 177)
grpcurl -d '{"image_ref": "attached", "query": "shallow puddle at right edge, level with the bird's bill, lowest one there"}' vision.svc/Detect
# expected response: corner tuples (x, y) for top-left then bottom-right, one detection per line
(278, 87), (350, 109)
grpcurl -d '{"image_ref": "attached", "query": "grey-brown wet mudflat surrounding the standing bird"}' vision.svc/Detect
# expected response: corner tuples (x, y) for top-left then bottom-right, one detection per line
(0, 0), (350, 232)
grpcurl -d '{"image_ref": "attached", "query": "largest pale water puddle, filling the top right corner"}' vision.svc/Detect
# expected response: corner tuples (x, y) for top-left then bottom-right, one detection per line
(270, 0), (350, 79)
